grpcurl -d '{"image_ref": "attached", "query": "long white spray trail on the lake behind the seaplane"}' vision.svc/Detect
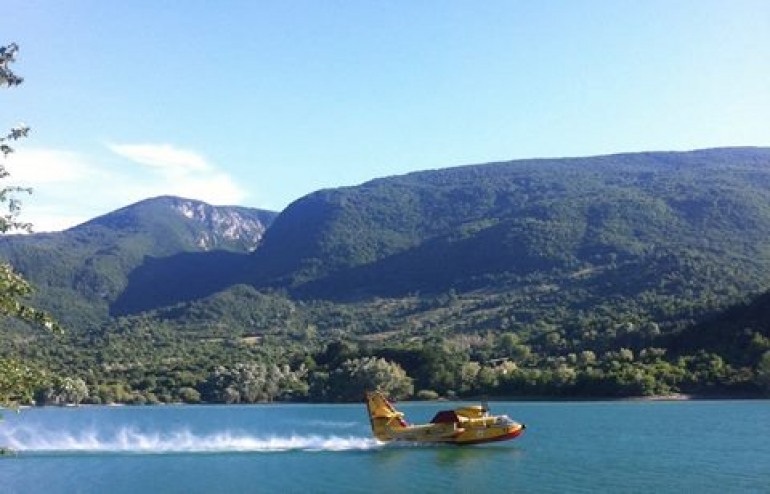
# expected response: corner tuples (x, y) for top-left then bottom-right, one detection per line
(0, 428), (382, 454)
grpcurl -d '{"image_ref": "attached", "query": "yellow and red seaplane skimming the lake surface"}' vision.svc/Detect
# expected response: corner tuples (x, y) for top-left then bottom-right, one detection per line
(366, 391), (526, 444)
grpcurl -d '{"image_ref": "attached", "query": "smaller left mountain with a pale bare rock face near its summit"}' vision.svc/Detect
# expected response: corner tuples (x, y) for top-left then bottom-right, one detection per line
(0, 196), (277, 325)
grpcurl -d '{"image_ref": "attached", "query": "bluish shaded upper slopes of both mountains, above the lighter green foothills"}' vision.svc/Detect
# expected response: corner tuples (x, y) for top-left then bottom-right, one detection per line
(0, 148), (770, 332)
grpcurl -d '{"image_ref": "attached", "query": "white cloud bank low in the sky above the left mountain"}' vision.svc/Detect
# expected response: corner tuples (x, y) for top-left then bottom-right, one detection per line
(2, 144), (247, 232)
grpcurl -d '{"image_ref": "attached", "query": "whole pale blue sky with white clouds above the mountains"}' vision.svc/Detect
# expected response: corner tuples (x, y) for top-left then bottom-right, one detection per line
(0, 0), (770, 231)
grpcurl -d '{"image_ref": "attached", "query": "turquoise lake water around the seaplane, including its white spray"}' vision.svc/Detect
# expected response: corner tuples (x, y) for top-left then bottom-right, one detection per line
(0, 401), (770, 494)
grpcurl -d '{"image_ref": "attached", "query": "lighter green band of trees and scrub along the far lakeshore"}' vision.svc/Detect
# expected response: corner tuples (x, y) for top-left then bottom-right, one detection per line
(5, 288), (770, 404)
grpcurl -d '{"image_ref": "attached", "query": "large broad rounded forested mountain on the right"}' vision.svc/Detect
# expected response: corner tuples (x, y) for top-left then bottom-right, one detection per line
(252, 148), (770, 310)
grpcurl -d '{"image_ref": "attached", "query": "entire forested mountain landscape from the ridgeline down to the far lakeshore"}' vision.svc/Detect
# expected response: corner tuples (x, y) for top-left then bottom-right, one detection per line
(0, 148), (770, 403)
